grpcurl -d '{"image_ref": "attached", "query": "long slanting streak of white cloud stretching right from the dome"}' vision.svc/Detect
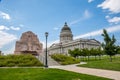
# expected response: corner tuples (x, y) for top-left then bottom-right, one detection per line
(74, 25), (120, 39)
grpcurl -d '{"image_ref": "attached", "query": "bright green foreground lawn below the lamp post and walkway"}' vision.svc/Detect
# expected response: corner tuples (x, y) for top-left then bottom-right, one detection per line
(0, 68), (111, 80)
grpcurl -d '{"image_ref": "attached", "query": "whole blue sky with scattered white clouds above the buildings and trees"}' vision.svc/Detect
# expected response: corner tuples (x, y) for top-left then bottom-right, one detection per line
(0, 0), (120, 54)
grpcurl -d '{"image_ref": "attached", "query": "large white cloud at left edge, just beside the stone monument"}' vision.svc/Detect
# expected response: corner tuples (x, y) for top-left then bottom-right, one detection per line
(0, 31), (17, 48)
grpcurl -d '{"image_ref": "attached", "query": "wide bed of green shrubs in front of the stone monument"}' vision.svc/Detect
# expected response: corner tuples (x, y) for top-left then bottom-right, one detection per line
(0, 55), (43, 67)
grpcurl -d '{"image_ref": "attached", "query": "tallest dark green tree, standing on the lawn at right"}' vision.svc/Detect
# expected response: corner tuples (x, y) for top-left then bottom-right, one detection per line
(102, 29), (116, 61)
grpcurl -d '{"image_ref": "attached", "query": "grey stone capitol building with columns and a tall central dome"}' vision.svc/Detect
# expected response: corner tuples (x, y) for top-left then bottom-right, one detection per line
(48, 23), (101, 55)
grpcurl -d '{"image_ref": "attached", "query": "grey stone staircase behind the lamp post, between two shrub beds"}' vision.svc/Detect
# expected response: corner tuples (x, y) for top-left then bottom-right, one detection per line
(38, 55), (60, 66)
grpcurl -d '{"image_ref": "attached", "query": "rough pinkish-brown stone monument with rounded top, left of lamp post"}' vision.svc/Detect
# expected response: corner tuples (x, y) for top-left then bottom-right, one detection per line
(14, 31), (43, 56)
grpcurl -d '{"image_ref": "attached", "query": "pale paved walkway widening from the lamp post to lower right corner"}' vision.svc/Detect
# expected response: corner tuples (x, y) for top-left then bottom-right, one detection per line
(50, 65), (120, 80)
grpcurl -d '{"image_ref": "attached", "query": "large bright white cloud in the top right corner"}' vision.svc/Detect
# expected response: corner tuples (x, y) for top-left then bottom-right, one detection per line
(97, 0), (120, 13)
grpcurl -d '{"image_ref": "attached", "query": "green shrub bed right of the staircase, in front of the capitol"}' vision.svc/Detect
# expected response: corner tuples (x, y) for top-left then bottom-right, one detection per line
(51, 54), (80, 65)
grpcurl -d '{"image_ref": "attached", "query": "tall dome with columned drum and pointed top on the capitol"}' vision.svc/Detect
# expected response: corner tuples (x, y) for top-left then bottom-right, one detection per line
(60, 22), (73, 42)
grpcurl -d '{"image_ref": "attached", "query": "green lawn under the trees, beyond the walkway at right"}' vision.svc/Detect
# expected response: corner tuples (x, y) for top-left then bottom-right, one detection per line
(78, 56), (120, 71)
